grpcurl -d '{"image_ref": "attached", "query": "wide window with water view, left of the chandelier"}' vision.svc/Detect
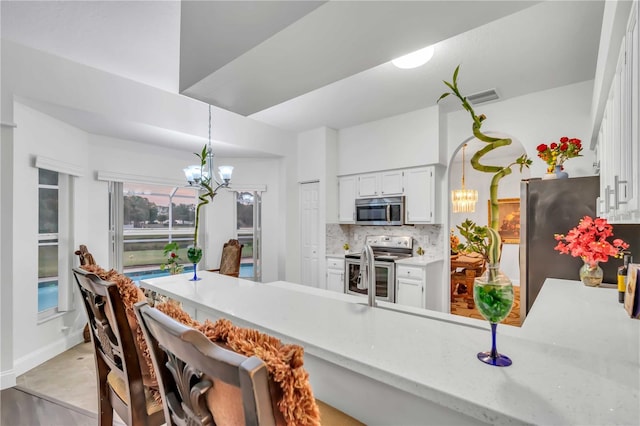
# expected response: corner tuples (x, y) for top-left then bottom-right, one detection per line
(111, 182), (198, 281)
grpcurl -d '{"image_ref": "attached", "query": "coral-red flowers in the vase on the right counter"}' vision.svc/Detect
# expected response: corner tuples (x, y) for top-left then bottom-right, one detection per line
(554, 216), (629, 267)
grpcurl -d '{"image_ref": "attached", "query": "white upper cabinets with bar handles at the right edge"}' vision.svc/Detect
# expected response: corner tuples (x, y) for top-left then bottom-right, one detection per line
(597, 2), (640, 223)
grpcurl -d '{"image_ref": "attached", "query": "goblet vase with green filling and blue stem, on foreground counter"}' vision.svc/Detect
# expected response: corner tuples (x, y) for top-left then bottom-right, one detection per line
(473, 263), (513, 367)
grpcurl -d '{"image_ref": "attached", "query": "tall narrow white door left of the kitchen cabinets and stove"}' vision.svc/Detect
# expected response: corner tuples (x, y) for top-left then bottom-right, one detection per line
(300, 182), (320, 287)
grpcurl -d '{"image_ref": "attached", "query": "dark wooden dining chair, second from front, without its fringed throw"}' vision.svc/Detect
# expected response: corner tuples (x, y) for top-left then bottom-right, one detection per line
(73, 268), (164, 426)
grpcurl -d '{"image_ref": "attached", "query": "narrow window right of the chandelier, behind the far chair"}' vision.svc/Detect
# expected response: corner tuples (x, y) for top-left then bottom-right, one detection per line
(236, 191), (262, 281)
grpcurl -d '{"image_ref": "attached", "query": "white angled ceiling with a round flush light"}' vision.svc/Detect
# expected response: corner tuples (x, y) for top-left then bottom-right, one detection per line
(1, 0), (604, 155)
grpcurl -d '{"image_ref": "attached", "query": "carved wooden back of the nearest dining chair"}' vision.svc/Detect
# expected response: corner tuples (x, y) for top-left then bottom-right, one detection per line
(135, 302), (276, 426)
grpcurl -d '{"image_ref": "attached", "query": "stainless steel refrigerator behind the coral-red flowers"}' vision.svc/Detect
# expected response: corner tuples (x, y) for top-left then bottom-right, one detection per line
(520, 176), (640, 318)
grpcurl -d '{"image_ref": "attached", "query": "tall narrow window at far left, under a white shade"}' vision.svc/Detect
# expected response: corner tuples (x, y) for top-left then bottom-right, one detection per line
(38, 168), (73, 320)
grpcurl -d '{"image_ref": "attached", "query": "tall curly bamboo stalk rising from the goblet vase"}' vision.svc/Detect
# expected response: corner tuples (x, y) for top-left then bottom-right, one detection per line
(438, 65), (532, 264)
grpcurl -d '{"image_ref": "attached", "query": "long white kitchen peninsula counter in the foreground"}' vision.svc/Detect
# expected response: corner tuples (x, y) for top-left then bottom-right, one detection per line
(141, 272), (640, 425)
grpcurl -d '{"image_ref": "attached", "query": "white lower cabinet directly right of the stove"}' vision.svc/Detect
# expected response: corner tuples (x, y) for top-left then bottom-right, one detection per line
(396, 260), (443, 311)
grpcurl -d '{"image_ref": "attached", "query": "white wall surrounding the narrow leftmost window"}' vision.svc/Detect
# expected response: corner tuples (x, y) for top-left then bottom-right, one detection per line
(11, 103), (90, 375)
